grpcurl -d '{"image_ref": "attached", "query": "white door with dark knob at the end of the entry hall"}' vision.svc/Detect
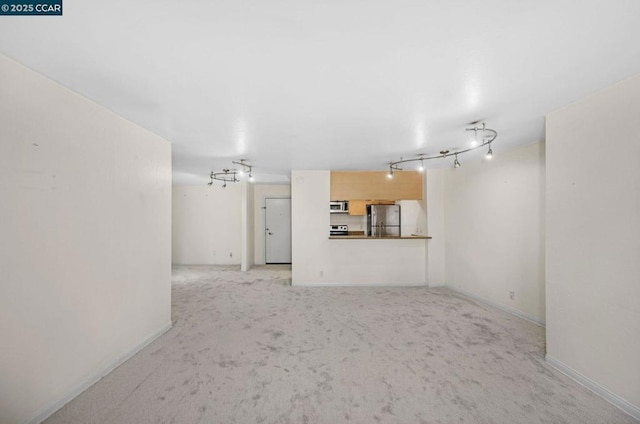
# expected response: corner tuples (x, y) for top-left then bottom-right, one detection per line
(264, 198), (291, 264)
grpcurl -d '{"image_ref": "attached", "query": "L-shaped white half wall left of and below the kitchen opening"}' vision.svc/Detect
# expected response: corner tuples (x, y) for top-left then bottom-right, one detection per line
(291, 171), (428, 285)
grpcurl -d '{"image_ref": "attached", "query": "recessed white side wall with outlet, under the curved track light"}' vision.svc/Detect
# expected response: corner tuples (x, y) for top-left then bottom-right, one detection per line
(444, 143), (545, 322)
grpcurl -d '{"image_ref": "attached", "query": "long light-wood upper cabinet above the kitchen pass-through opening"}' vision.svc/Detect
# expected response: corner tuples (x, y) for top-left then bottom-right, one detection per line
(331, 171), (423, 200)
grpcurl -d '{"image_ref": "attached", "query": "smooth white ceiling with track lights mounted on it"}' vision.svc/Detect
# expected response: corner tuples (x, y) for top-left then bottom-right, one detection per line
(0, 0), (640, 184)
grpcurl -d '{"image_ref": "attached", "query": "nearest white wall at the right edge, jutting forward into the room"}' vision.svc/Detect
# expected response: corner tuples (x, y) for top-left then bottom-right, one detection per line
(546, 75), (640, 418)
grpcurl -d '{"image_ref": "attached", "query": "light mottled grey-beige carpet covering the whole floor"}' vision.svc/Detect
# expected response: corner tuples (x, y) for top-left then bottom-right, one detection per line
(46, 266), (636, 424)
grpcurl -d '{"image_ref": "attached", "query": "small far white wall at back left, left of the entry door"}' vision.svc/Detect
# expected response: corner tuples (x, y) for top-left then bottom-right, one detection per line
(172, 184), (242, 265)
